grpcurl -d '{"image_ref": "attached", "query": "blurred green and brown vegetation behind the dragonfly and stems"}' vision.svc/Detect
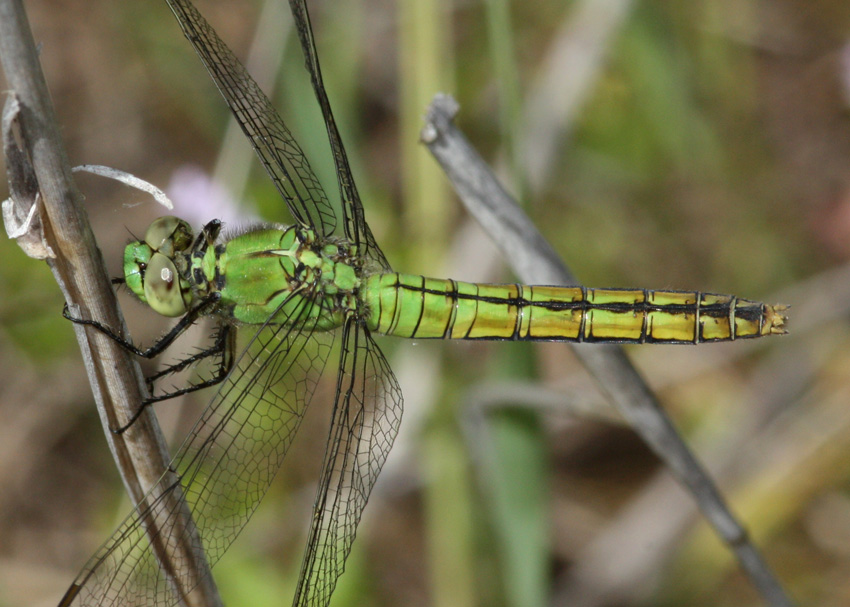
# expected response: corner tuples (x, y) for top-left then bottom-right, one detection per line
(0, 0), (850, 607)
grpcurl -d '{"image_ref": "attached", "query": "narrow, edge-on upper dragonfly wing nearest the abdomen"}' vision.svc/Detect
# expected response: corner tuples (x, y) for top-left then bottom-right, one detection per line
(289, 0), (390, 270)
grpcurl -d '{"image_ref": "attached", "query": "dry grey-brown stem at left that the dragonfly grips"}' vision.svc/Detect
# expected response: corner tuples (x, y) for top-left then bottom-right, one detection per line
(0, 0), (221, 605)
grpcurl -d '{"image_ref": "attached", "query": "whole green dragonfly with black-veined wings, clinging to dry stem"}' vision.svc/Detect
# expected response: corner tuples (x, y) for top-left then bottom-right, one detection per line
(59, 0), (786, 607)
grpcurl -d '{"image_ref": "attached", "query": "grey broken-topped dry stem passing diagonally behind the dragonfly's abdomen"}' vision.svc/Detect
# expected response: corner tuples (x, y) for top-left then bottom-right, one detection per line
(422, 96), (793, 606)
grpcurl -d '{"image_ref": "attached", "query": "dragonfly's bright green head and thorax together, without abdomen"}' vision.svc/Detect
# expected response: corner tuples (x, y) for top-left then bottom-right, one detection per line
(124, 217), (360, 330)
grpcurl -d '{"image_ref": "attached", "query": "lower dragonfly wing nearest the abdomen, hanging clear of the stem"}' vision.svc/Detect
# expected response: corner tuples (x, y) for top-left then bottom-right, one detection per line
(293, 321), (402, 607)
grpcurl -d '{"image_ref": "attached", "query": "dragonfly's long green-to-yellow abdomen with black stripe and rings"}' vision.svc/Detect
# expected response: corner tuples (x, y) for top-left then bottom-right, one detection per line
(361, 273), (785, 343)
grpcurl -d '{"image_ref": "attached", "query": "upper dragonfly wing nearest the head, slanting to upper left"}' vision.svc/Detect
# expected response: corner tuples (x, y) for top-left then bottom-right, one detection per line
(168, 0), (336, 236)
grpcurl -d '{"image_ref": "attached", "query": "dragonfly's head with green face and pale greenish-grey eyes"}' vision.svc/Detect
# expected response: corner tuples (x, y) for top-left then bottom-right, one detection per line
(124, 216), (193, 317)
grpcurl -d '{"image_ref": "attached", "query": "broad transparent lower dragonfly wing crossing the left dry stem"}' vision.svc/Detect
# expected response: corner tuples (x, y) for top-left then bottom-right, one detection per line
(62, 299), (339, 607)
